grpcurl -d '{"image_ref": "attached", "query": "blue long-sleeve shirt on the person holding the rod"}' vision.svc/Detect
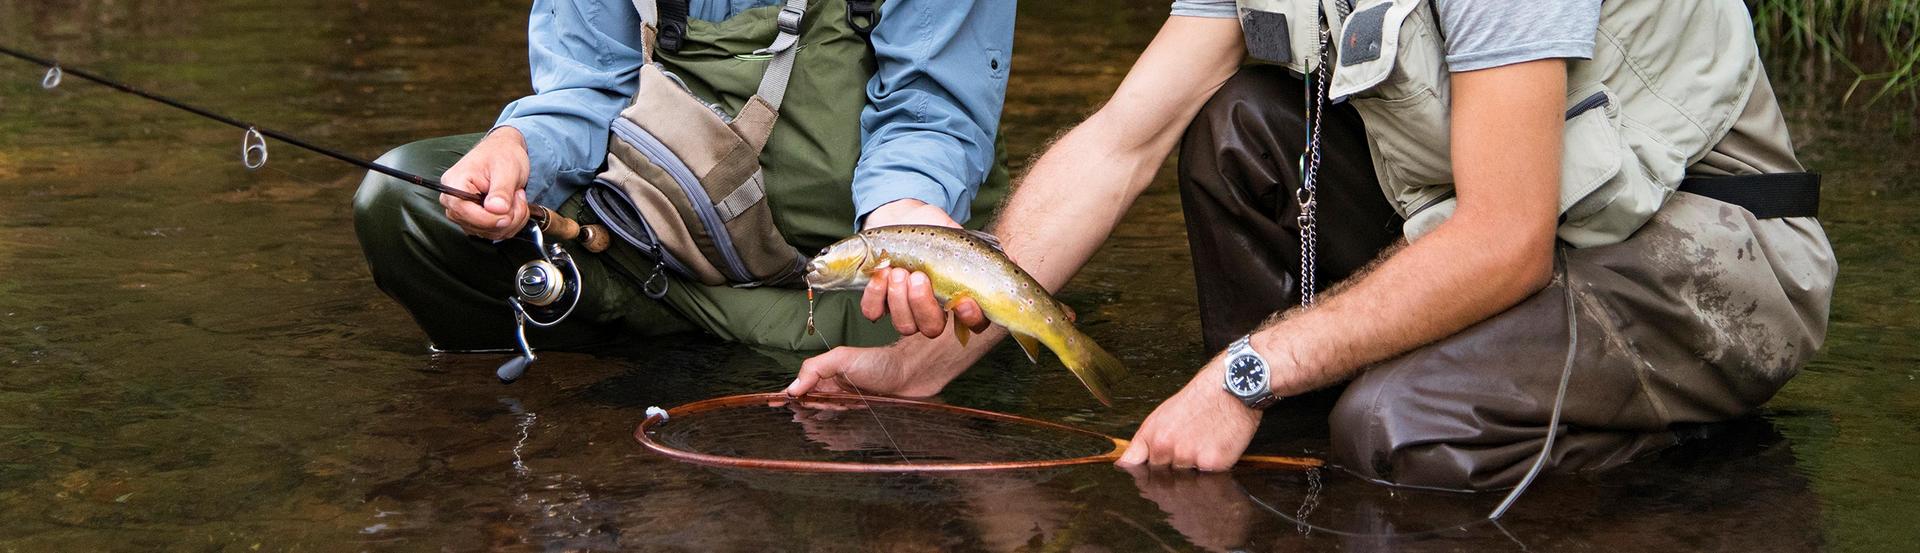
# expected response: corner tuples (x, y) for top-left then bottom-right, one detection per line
(495, 0), (1014, 225)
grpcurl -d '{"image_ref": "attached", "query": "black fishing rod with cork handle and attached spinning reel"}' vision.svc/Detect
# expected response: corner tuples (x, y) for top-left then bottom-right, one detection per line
(0, 46), (612, 382)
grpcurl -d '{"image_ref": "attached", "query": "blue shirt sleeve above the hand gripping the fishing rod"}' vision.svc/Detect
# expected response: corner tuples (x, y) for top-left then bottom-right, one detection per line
(493, 0), (641, 207)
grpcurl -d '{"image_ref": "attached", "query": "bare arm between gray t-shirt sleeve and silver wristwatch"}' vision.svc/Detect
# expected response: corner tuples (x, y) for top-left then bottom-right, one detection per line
(1254, 60), (1567, 396)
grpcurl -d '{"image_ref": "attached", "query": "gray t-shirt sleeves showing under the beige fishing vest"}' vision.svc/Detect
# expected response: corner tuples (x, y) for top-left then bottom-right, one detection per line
(1173, 0), (1599, 71)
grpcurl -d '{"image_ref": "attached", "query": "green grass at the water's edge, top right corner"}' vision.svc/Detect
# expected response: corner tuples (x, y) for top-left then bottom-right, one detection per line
(1747, 0), (1920, 106)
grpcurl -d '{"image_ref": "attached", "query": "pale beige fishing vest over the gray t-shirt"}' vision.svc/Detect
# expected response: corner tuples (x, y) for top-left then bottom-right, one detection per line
(1236, 0), (1778, 248)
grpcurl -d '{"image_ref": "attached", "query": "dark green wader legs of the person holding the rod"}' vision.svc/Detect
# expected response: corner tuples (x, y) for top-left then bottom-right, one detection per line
(353, 134), (900, 351)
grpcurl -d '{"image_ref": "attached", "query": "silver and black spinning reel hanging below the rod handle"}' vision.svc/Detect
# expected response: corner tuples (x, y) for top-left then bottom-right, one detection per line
(493, 225), (580, 384)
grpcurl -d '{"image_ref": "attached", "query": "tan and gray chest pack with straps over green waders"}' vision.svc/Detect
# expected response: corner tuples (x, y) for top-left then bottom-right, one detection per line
(588, 0), (806, 294)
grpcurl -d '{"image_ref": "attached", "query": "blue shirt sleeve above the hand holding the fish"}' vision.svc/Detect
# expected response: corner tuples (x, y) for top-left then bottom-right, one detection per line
(852, 0), (1014, 223)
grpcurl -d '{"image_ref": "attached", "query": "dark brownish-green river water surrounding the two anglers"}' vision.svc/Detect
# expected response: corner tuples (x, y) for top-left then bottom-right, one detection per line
(0, 0), (1920, 551)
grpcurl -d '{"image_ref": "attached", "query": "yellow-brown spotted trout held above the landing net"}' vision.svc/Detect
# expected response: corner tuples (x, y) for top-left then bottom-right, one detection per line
(806, 225), (1127, 407)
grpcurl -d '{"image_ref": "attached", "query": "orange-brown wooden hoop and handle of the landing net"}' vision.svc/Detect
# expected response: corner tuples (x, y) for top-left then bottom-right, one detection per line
(634, 392), (1325, 472)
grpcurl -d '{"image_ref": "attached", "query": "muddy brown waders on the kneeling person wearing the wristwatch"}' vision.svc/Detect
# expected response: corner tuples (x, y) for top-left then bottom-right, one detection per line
(1179, 65), (1836, 490)
